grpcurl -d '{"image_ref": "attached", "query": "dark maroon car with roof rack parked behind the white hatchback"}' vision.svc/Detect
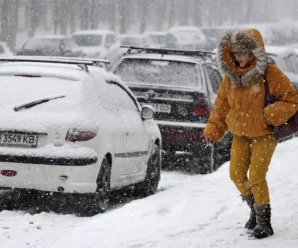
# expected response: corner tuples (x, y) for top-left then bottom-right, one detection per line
(112, 47), (231, 173)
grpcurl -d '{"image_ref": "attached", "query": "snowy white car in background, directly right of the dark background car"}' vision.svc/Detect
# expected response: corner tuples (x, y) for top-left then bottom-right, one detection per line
(71, 29), (123, 65)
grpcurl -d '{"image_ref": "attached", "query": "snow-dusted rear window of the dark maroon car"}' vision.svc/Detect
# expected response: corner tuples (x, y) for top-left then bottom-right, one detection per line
(114, 59), (199, 87)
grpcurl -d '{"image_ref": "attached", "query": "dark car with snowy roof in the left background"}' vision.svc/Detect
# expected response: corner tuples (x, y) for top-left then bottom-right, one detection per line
(16, 35), (83, 57)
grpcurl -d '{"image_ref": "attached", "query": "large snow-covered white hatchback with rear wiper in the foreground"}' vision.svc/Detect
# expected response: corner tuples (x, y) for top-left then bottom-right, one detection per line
(0, 57), (161, 212)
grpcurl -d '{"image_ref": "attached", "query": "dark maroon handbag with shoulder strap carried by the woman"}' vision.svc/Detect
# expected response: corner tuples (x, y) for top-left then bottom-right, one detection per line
(264, 74), (298, 140)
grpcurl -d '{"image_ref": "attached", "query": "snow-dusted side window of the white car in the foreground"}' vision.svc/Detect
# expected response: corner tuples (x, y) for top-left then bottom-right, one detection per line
(108, 81), (139, 112)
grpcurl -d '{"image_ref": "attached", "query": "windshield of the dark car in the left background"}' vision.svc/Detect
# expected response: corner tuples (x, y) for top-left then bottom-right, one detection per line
(23, 38), (61, 51)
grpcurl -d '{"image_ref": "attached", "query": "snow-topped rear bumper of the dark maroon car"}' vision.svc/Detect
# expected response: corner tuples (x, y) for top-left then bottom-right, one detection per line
(156, 121), (206, 151)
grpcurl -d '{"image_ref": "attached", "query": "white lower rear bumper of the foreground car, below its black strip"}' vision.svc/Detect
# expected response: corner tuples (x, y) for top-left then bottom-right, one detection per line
(0, 159), (99, 193)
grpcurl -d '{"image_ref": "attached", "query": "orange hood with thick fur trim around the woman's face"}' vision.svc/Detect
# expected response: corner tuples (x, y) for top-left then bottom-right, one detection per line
(217, 29), (267, 88)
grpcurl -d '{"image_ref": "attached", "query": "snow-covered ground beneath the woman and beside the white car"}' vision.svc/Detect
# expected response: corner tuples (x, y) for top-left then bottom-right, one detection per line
(0, 138), (298, 248)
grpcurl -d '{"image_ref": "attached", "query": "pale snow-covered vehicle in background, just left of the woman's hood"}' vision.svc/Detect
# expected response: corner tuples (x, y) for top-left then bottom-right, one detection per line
(168, 26), (207, 50)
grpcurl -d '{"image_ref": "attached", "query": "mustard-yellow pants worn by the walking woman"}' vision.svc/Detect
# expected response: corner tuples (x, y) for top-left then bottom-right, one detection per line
(230, 135), (278, 204)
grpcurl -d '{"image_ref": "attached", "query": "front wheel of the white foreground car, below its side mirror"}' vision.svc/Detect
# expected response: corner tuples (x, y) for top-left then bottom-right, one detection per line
(137, 144), (161, 197)
